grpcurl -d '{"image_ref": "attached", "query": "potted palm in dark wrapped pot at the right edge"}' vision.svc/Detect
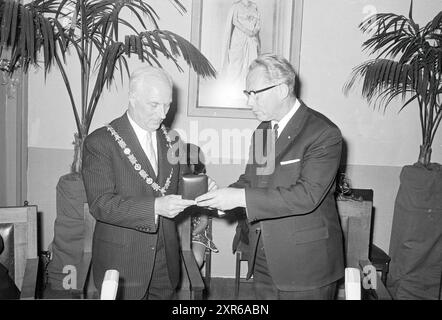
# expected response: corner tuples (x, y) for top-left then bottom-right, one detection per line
(344, 2), (442, 299)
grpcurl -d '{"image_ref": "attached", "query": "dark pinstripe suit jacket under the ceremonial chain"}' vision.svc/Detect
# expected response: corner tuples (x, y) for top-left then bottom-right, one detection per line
(82, 114), (185, 299)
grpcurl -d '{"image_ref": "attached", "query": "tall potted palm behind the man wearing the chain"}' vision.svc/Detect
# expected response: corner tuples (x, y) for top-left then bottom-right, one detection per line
(0, 0), (215, 296)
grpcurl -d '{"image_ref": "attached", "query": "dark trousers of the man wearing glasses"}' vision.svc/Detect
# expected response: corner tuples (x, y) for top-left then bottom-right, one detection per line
(253, 241), (337, 300)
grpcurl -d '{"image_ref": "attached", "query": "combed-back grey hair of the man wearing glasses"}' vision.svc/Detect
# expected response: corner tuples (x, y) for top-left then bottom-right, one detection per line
(249, 53), (296, 95)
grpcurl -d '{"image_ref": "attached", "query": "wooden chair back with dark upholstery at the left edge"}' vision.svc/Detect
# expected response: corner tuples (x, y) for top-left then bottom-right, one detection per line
(0, 206), (38, 291)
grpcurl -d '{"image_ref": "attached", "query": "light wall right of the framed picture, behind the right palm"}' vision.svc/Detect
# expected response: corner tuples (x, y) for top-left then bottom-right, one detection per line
(300, 0), (442, 258)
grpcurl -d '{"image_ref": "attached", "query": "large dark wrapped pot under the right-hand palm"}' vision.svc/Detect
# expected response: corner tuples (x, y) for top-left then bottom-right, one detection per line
(387, 164), (442, 300)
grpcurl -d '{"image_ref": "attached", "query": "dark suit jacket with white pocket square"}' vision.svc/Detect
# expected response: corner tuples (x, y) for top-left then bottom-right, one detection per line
(232, 103), (344, 291)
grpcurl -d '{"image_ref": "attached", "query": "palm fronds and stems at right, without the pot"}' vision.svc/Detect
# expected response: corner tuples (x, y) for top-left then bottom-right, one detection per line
(344, 1), (442, 167)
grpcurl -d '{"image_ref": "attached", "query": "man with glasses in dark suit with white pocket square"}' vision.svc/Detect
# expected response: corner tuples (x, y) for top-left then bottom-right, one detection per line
(196, 54), (344, 299)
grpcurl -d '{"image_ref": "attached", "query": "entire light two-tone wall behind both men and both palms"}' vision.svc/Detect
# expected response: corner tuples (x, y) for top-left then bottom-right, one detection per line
(28, 0), (442, 277)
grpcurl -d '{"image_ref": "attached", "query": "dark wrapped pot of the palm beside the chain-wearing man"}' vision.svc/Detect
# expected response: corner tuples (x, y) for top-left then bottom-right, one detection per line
(47, 173), (86, 290)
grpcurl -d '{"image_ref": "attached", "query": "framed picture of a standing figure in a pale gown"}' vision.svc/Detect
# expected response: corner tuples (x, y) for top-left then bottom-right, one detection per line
(187, 0), (303, 119)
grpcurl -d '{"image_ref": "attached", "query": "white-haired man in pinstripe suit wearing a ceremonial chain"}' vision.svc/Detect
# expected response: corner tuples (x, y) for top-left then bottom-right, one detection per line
(82, 67), (213, 299)
